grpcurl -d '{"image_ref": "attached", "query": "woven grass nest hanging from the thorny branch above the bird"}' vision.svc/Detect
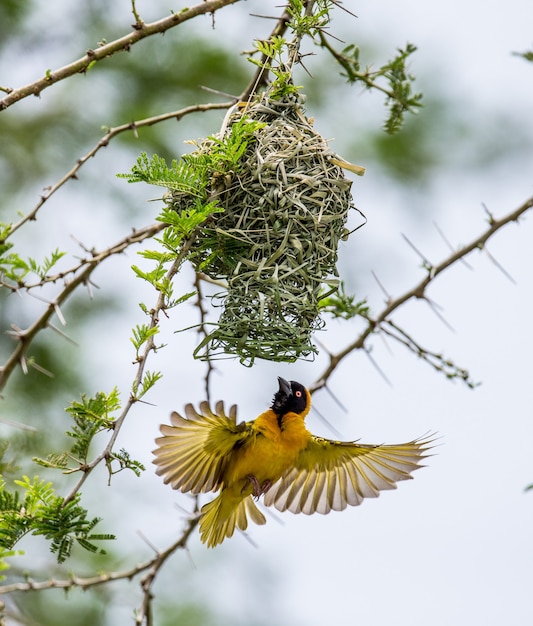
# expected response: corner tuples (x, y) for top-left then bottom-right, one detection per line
(168, 93), (364, 364)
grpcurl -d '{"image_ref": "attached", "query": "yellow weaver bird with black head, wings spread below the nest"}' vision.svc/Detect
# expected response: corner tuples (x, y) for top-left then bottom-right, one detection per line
(153, 378), (431, 548)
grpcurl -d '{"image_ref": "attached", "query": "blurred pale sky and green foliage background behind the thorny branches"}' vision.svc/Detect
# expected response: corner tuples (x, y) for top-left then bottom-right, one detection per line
(0, 0), (533, 626)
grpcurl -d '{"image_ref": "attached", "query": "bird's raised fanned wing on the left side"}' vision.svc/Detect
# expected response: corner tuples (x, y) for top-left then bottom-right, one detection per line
(153, 402), (251, 494)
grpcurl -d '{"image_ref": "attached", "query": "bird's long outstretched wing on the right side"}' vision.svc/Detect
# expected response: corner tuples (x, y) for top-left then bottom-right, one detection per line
(264, 437), (431, 515)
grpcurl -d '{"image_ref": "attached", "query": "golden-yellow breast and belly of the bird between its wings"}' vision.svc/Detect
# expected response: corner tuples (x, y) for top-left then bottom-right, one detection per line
(224, 411), (311, 492)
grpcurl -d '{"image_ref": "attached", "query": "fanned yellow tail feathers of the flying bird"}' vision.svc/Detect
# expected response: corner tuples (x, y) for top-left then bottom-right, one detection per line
(200, 491), (266, 548)
